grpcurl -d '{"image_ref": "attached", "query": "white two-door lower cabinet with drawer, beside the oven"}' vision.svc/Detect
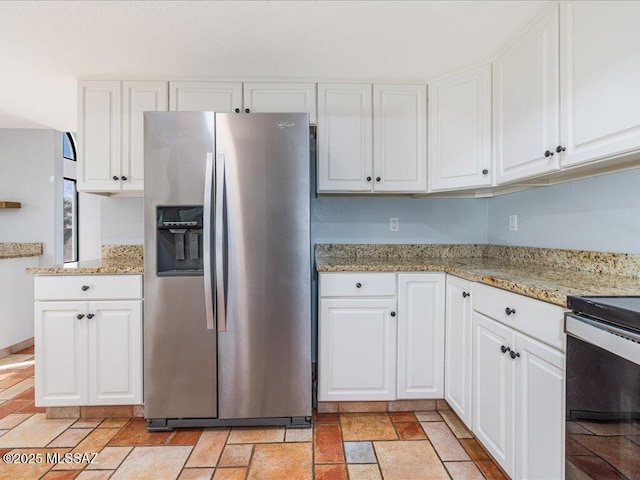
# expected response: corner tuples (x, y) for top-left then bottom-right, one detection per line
(473, 287), (565, 480)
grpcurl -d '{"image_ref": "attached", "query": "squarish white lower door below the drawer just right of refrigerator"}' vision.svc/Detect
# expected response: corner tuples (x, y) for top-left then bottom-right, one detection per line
(318, 299), (396, 402)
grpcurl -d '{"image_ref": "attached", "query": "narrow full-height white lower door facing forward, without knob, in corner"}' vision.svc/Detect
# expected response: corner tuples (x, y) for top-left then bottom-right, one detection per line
(397, 273), (444, 399)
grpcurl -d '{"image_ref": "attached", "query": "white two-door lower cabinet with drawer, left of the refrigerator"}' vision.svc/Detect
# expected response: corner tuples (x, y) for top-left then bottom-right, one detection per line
(34, 276), (142, 407)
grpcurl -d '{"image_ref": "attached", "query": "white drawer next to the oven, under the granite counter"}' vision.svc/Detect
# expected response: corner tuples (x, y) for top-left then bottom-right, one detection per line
(473, 283), (565, 351)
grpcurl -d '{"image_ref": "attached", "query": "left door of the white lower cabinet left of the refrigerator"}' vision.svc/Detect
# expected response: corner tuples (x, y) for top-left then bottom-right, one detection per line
(34, 302), (89, 407)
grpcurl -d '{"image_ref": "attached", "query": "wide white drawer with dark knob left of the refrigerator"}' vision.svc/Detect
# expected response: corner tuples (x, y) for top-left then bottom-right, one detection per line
(34, 275), (142, 300)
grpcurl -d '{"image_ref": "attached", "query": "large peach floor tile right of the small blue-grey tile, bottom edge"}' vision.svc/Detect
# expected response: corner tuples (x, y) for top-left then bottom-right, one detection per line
(373, 440), (449, 480)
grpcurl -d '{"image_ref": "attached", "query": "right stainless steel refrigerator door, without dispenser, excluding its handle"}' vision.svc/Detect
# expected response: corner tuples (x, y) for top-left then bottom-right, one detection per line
(216, 113), (311, 419)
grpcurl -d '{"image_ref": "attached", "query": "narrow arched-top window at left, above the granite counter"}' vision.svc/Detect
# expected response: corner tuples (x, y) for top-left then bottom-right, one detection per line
(62, 132), (78, 263)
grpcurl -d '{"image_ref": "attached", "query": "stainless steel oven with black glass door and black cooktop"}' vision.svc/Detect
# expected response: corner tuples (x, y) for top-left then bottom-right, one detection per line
(565, 297), (640, 480)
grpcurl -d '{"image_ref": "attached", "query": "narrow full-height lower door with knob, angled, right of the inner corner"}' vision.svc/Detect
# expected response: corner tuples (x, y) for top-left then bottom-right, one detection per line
(444, 275), (473, 428)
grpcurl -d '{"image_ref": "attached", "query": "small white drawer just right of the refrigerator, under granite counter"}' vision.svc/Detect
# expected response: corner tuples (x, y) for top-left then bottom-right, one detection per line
(320, 273), (396, 297)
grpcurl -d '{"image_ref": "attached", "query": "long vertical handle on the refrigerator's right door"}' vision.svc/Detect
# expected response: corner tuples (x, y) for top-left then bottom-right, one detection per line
(215, 154), (227, 332)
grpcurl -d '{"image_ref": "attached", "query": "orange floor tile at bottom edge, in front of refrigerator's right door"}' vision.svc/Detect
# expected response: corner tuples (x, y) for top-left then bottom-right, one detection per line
(247, 443), (313, 480)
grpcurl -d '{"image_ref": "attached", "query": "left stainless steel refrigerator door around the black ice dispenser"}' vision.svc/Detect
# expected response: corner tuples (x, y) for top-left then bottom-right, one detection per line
(144, 112), (217, 418)
